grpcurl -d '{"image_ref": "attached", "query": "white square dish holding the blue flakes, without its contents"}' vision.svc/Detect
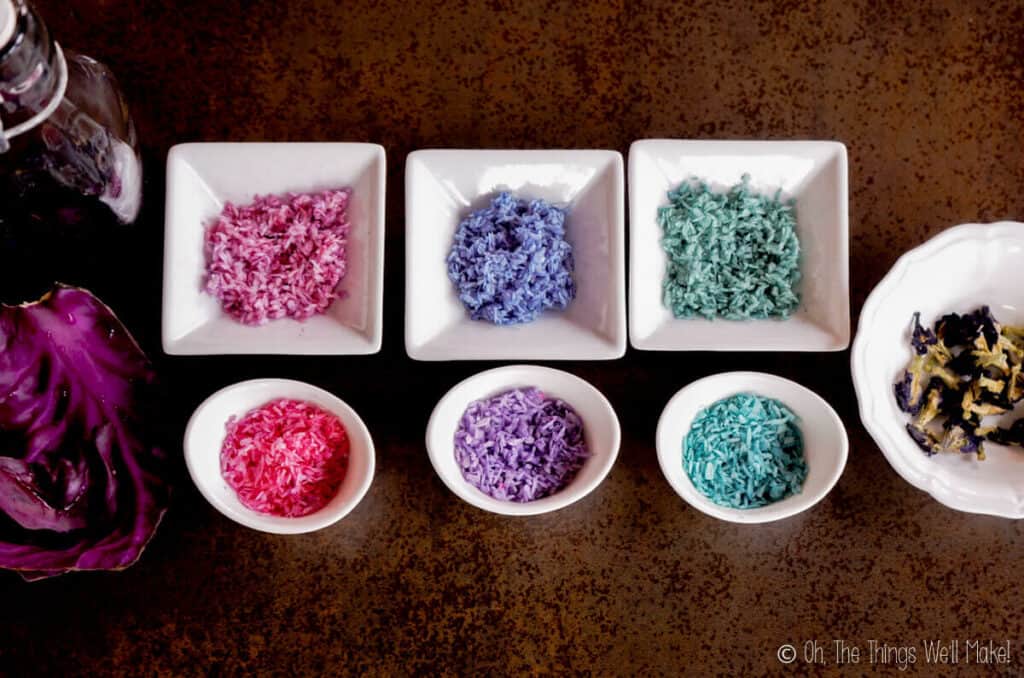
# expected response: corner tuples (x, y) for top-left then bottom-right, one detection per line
(406, 151), (626, 361)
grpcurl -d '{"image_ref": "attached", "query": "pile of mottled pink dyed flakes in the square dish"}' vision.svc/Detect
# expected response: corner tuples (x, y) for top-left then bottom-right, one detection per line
(204, 188), (351, 325)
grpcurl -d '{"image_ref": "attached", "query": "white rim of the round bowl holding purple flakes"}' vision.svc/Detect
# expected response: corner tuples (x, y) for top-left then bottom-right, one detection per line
(425, 365), (622, 516)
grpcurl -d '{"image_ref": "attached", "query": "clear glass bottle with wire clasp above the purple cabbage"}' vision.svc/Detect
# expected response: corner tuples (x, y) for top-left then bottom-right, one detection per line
(0, 0), (142, 301)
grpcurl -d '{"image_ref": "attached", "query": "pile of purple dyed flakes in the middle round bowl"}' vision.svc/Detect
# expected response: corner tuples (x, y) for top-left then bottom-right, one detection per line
(455, 387), (590, 502)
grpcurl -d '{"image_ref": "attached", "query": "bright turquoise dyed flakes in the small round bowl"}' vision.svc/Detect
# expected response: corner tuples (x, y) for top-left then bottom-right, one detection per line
(683, 393), (807, 509)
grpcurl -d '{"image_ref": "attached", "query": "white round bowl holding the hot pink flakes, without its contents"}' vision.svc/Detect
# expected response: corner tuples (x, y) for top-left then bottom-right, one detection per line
(184, 379), (375, 535)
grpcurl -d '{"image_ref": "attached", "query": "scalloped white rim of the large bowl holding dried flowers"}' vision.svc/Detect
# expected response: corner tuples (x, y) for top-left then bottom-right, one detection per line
(850, 221), (1024, 518)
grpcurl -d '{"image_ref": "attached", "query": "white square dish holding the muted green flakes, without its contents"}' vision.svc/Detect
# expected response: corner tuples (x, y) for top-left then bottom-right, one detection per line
(630, 139), (850, 351)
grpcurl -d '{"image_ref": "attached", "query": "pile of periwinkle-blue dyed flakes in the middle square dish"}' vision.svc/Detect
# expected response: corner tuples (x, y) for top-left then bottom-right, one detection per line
(447, 193), (575, 325)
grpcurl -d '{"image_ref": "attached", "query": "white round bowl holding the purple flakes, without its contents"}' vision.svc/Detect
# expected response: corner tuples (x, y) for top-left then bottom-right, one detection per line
(427, 365), (622, 515)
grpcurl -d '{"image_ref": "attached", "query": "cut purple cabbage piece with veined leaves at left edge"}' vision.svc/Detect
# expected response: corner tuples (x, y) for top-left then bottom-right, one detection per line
(0, 286), (169, 580)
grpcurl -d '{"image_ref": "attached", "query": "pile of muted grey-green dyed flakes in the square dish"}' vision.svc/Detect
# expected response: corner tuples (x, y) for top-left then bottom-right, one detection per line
(657, 175), (800, 321)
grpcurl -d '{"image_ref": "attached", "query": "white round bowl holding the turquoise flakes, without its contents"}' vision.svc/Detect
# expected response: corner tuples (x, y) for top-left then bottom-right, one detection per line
(657, 372), (849, 523)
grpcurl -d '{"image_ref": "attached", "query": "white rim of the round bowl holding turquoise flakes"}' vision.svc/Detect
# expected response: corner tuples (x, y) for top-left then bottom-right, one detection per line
(655, 371), (850, 524)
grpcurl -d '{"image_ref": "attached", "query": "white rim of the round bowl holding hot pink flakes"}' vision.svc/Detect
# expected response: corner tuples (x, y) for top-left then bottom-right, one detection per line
(183, 378), (377, 535)
